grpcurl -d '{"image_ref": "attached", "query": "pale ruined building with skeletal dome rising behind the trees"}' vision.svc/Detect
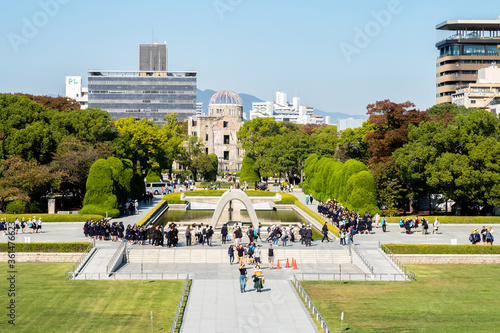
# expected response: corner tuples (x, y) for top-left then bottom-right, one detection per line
(188, 90), (244, 171)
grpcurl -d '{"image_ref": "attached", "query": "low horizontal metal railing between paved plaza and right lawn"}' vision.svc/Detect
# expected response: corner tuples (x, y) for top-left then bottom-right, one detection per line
(295, 272), (408, 281)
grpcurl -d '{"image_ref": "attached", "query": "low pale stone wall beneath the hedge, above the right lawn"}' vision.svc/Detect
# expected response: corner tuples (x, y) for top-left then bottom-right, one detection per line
(395, 254), (500, 265)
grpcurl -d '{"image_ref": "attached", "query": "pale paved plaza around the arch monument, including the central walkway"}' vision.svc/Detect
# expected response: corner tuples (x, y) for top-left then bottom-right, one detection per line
(0, 189), (494, 333)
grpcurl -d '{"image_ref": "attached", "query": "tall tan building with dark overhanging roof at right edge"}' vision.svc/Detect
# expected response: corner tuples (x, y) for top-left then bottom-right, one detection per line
(436, 16), (500, 104)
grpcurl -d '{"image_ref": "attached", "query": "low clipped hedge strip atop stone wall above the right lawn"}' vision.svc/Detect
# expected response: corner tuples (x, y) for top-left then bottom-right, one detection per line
(385, 244), (500, 254)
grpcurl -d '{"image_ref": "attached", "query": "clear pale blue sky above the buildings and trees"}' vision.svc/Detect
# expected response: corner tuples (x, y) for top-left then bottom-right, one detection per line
(0, 0), (500, 115)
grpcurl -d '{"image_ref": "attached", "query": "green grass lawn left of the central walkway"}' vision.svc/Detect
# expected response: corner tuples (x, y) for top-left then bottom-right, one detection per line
(0, 263), (184, 332)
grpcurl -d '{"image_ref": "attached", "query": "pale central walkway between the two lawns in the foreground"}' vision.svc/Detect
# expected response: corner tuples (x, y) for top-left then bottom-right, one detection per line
(181, 278), (317, 333)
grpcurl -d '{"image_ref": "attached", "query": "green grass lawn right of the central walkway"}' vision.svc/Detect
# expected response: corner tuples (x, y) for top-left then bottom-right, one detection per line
(301, 265), (500, 332)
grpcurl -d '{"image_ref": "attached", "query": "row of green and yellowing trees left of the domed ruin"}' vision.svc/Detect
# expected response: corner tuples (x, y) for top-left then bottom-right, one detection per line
(0, 94), (217, 212)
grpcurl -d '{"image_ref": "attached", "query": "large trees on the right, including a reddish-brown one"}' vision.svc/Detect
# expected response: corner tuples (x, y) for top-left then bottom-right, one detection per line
(336, 100), (500, 214)
